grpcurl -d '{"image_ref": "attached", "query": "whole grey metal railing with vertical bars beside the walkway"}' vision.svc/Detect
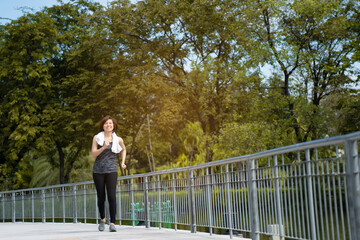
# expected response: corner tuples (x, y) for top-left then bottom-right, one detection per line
(0, 132), (360, 240)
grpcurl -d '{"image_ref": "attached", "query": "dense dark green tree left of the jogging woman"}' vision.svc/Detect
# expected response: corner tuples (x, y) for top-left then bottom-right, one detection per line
(0, 1), (111, 188)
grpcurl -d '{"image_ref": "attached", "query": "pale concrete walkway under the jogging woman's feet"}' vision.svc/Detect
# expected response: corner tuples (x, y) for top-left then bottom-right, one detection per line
(0, 222), (250, 240)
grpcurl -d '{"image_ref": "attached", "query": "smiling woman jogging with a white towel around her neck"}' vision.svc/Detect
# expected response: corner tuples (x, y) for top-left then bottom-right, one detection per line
(91, 116), (126, 232)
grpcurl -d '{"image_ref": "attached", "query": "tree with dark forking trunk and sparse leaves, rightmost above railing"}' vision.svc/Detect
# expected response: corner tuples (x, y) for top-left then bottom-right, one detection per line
(253, 0), (356, 142)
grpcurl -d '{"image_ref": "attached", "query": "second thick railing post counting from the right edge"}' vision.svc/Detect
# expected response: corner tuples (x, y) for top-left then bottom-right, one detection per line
(247, 160), (260, 240)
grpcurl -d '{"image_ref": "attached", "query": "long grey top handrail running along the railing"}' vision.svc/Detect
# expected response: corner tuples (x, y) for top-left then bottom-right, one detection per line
(0, 131), (360, 194)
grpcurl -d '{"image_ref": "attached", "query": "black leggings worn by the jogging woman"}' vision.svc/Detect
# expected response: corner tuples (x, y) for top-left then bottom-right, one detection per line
(93, 172), (118, 223)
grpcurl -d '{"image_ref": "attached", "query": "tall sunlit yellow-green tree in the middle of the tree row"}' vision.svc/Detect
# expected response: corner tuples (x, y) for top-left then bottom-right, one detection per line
(108, 0), (258, 161)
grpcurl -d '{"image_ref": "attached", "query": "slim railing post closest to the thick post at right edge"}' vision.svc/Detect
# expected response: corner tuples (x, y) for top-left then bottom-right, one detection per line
(305, 149), (316, 240)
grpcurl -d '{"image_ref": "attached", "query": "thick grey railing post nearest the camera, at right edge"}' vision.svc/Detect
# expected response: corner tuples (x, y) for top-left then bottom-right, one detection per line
(344, 140), (360, 240)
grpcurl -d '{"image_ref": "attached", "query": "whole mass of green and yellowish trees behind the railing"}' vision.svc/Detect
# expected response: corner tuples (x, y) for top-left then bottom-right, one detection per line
(0, 0), (360, 189)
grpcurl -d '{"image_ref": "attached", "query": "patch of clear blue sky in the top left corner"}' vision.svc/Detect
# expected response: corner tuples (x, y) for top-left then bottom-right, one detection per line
(0, 0), (110, 24)
